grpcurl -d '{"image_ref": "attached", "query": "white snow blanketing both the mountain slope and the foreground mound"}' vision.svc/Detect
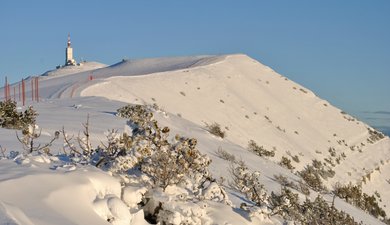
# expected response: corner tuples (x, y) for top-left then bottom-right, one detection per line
(0, 54), (390, 224)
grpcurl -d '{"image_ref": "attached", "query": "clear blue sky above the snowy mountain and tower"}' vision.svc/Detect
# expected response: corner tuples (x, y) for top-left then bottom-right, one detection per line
(0, 0), (390, 134)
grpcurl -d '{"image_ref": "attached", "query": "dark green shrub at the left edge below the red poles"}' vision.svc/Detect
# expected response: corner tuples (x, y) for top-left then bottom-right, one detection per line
(0, 100), (38, 129)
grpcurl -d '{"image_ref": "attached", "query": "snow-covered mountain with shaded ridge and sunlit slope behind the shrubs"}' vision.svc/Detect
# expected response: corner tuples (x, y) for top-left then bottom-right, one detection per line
(0, 54), (390, 224)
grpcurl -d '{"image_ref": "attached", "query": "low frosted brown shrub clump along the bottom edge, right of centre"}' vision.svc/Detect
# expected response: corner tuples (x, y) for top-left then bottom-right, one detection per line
(231, 159), (358, 225)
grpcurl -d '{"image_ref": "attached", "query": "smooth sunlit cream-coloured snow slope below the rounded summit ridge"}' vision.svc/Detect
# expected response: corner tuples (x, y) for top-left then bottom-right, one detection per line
(81, 55), (390, 189)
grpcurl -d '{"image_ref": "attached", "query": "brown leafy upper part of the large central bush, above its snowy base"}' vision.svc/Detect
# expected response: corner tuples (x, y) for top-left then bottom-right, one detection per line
(110, 105), (213, 193)
